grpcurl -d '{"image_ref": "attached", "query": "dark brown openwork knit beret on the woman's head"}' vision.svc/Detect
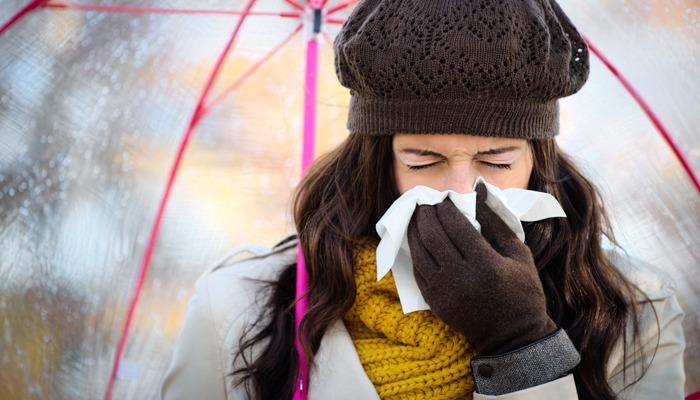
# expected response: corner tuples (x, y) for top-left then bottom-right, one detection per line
(334, 0), (589, 139)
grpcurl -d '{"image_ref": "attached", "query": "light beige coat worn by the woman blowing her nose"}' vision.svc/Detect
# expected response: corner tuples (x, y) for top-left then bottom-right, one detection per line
(161, 239), (685, 400)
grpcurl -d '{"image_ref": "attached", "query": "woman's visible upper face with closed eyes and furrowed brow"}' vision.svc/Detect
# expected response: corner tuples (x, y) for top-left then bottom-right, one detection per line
(392, 134), (532, 194)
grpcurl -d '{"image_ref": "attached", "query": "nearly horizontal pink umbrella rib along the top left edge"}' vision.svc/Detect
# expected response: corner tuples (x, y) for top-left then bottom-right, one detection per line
(44, 2), (301, 18)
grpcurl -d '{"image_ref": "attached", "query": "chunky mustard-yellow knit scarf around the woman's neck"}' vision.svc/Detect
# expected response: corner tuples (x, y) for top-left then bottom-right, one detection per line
(344, 243), (474, 399)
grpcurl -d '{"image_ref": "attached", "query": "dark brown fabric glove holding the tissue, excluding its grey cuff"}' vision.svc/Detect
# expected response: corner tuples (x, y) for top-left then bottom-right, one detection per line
(408, 184), (557, 355)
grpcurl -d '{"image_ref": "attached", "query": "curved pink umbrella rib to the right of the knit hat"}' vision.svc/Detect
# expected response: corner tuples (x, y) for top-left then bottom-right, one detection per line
(584, 37), (700, 192)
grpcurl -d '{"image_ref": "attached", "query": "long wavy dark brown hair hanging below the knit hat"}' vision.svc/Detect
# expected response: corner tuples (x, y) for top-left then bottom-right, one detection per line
(233, 134), (639, 399)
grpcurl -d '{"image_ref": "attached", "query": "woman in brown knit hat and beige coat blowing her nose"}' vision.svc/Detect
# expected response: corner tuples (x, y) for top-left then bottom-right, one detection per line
(162, 0), (684, 399)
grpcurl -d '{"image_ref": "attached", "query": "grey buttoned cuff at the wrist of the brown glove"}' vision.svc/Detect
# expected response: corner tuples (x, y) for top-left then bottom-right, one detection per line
(471, 329), (581, 396)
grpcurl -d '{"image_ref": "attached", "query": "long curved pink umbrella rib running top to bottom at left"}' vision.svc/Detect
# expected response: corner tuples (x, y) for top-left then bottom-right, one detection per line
(105, 0), (256, 400)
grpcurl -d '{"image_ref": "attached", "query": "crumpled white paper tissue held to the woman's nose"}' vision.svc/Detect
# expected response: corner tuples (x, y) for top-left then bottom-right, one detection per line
(376, 177), (566, 314)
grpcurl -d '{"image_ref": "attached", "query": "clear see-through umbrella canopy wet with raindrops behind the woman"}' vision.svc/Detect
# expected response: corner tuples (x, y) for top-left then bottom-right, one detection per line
(0, 0), (700, 399)
